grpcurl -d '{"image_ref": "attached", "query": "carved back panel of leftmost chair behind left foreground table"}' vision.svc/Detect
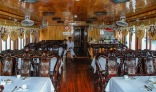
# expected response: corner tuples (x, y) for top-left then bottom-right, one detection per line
(3, 57), (13, 76)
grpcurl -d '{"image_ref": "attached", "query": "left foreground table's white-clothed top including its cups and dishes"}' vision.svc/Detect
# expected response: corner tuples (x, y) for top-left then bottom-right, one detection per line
(0, 75), (55, 92)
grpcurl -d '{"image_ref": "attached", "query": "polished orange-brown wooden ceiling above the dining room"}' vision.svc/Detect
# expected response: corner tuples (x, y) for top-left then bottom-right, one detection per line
(0, 0), (156, 25)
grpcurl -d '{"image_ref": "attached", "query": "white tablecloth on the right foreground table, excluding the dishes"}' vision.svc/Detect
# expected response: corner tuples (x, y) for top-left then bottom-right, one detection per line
(105, 76), (156, 92)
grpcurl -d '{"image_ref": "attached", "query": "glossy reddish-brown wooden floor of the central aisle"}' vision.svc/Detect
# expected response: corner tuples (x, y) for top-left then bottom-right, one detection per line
(59, 58), (95, 92)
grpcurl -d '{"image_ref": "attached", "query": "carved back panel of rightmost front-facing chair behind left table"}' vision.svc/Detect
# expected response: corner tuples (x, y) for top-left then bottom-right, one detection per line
(39, 58), (50, 77)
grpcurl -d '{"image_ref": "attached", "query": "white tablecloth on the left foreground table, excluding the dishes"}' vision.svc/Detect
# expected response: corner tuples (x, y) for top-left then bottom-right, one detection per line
(0, 76), (54, 92)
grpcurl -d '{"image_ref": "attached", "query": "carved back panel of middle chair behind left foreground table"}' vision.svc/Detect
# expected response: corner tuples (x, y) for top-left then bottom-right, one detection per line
(20, 58), (31, 76)
